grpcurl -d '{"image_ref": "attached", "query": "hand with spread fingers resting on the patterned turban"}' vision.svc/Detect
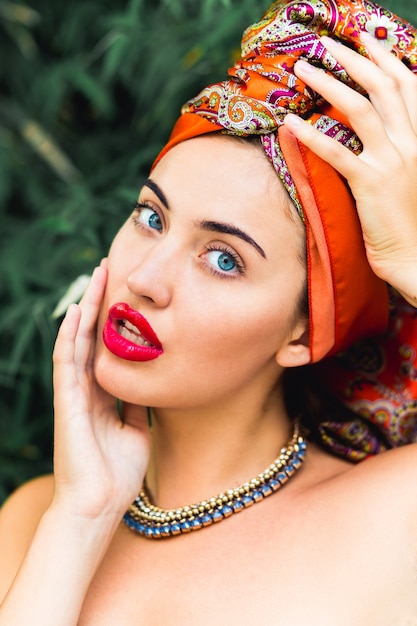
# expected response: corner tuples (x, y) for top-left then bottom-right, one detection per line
(285, 35), (417, 306)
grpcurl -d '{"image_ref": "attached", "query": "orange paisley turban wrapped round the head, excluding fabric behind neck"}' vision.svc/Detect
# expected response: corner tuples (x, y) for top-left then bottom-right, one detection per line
(155, 0), (417, 458)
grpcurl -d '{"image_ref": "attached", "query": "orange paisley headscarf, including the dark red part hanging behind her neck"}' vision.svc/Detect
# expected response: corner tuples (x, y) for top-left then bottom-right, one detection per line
(155, 0), (417, 459)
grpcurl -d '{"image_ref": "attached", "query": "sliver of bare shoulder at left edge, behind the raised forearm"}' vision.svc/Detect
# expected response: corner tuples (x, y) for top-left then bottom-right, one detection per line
(0, 475), (54, 601)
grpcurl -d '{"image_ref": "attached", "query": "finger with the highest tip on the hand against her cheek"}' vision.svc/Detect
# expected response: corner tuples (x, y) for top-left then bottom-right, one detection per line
(75, 267), (107, 368)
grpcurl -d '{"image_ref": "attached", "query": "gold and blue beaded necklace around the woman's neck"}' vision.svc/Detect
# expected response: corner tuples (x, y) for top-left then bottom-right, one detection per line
(123, 422), (307, 539)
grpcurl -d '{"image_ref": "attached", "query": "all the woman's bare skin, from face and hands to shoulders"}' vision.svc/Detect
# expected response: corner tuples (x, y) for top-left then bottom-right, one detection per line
(0, 35), (417, 626)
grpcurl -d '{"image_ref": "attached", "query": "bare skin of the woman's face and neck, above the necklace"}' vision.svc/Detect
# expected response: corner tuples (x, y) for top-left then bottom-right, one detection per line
(95, 136), (309, 507)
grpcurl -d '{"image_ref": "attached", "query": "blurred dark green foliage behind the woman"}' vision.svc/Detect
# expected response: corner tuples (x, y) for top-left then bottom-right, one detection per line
(0, 0), (417, 502)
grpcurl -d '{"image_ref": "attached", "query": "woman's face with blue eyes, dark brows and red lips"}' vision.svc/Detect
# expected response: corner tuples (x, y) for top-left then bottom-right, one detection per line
(96, 135), (309, 408)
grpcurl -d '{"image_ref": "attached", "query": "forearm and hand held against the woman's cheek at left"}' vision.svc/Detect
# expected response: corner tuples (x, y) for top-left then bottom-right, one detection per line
(0, 267), (149, 626)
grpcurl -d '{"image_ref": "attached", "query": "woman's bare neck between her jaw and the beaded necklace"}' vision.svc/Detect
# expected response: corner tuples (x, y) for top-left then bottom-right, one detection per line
(146, 382), (292, 508)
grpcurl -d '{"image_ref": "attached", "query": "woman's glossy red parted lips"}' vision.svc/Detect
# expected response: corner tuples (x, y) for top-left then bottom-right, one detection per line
(103, 302), (163, 361)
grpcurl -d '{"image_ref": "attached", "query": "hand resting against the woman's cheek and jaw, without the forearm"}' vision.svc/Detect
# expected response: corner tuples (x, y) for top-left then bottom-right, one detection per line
(54, 264), (150, 521)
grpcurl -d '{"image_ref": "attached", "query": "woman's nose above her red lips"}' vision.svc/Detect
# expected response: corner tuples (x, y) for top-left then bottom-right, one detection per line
(127, 240), (177, 307)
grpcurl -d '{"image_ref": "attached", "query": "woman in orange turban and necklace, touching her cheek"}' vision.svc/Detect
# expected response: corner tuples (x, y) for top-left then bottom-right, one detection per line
(0, 0), (417, 626)
